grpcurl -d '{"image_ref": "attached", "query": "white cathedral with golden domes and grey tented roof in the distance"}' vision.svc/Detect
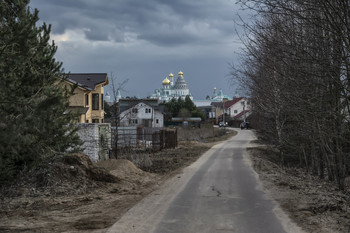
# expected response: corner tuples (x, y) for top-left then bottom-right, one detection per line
(150, 71), (193, 102)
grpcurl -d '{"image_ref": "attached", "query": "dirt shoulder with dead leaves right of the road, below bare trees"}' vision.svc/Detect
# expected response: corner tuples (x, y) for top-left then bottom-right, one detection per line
(248, 144), (350, 233)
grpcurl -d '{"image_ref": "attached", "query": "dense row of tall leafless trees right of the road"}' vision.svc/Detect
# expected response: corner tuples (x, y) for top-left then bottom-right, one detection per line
(235, 0), (350, 188)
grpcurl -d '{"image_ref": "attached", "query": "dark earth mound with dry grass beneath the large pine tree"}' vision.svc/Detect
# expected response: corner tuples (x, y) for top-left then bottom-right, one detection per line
(0, 154), (120, 198)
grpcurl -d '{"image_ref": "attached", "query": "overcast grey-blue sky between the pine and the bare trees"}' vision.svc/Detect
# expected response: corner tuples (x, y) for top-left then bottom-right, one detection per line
(30, 0), (246, 99)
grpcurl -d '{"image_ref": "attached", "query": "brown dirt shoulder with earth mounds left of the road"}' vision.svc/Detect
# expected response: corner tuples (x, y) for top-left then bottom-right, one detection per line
(0, 128), (237, 232)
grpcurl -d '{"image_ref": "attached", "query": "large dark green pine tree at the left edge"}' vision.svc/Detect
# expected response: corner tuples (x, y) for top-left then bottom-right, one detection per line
(0, 0), (80, 184)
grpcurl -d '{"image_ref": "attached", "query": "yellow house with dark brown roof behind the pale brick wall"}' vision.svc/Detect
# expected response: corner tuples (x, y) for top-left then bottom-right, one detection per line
(65, 73), (108, 123)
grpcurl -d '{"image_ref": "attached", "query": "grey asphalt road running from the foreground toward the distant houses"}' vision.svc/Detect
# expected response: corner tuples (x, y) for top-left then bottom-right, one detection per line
(108, 130), (301, 233)
